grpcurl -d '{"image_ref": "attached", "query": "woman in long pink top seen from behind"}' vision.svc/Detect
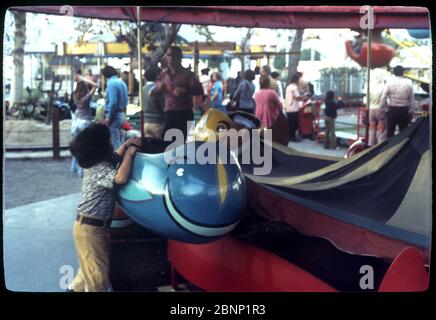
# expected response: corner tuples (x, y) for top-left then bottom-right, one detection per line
(254, 76), (282, 128)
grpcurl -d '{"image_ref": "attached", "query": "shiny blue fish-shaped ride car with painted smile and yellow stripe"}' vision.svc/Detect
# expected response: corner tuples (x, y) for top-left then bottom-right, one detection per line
(117, 141), (246, 243)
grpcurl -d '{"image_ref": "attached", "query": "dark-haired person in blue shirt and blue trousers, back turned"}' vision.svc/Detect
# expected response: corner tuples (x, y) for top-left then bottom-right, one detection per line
(102, 66), (128, 149)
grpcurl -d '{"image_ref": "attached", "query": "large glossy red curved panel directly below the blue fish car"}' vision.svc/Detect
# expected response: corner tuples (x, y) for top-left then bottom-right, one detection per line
(168, 236), (335, 292)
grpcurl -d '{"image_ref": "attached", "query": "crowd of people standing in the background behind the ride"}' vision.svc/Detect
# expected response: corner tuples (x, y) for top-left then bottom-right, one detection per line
(71, 46), (416, 176)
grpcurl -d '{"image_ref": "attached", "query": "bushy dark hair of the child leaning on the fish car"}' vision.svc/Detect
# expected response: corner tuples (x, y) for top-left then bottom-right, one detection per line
(70, 124), (116, 168)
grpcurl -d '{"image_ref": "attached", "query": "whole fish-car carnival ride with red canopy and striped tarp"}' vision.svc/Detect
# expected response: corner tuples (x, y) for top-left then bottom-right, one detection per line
(11, 6), (431, 292)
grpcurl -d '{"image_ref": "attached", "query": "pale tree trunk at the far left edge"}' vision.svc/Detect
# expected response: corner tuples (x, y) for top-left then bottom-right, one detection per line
(11, 11), (26, 106)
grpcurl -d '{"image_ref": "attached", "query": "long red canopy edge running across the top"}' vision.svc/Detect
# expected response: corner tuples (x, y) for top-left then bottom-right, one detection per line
(9, 6), (430, 29)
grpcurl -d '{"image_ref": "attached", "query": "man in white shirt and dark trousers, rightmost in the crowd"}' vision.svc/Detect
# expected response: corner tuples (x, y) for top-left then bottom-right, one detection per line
(380, 66), (416, 138)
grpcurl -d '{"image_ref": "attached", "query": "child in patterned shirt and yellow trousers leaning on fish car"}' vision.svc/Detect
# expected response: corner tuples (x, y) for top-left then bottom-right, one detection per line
(67, 124), (142, 292)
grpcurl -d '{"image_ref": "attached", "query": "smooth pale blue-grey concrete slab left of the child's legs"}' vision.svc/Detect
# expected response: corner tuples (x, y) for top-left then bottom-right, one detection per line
(3, 193), (80, 292)
